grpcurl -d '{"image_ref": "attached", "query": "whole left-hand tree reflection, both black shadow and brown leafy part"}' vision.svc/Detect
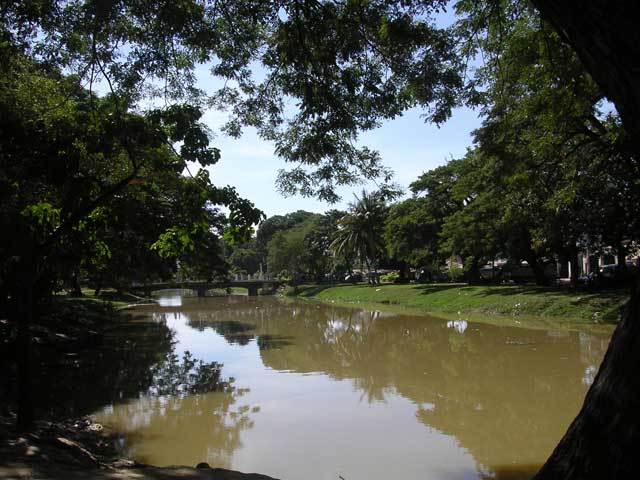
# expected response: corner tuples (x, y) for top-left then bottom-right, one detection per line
(5, 308), (259, 467)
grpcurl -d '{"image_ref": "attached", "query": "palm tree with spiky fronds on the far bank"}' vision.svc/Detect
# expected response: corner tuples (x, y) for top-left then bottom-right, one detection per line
(331, 190), (387, 283)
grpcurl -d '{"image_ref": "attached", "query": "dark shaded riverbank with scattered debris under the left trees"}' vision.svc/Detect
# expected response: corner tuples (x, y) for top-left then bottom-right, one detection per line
(0, 292), (273, 480)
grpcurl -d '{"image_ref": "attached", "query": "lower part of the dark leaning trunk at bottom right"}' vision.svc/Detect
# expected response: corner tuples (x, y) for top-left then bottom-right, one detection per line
(534, 287), (640, 480)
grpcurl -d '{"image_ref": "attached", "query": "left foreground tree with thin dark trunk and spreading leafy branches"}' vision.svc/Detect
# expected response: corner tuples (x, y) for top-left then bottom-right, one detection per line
(0, 8), (260, 429)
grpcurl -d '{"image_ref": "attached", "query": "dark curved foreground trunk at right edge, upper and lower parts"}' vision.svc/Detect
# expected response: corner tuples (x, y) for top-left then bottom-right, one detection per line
(531, 0), (640, 480)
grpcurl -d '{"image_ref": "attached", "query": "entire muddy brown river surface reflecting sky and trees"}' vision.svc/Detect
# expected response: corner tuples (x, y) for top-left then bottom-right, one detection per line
(87, 297), (609, 480)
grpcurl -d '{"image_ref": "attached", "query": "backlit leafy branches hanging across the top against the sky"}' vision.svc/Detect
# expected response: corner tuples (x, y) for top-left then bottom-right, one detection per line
(0, 0), (464, 200)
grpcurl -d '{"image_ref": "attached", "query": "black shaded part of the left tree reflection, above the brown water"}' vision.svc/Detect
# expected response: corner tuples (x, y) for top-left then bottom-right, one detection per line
(21, 319), (248, 418)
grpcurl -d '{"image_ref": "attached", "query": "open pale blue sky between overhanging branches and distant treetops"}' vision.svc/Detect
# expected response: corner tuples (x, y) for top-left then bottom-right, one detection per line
(204, 108), (480, 216)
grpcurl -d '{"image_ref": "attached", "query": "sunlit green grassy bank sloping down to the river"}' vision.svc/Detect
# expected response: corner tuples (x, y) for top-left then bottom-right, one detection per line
(284, 284), (629, 329)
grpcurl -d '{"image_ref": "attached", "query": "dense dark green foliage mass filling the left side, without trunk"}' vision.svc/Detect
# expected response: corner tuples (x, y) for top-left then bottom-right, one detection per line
(0, 18), (262, 301)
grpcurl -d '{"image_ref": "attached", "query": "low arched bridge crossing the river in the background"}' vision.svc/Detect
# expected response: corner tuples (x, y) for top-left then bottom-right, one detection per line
(131, 274), (285, 297)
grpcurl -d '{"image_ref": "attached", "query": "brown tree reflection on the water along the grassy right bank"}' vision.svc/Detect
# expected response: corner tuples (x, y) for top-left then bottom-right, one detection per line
(156, 300), (608, 478)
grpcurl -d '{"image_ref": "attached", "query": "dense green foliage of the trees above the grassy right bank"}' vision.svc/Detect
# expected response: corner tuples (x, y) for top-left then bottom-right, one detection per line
(376, 0), (640, 283)
